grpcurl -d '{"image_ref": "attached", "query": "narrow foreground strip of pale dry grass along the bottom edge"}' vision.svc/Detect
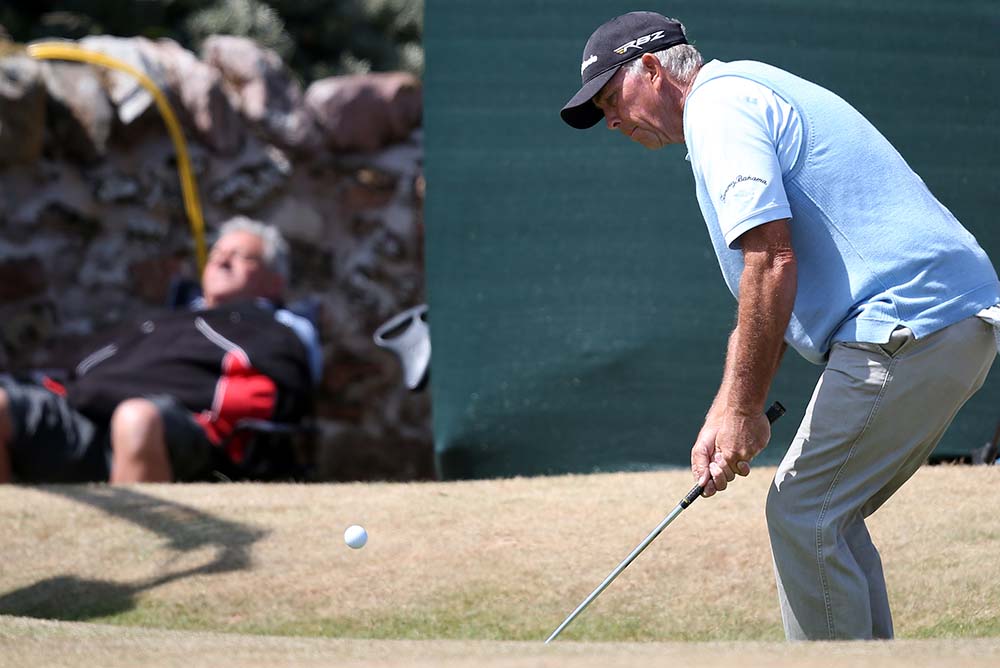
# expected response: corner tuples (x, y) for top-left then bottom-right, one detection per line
(0, 616), (1000, 668)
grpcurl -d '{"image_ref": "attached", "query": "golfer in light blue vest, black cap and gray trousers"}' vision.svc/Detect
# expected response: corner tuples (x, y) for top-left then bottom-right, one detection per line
(561, 12), (1000, 640)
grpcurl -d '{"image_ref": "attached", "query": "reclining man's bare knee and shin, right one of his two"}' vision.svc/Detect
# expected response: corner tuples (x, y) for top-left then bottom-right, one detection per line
(111, 399), (173, 483)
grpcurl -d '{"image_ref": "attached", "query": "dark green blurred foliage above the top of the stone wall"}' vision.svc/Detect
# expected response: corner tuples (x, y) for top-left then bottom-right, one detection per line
(0, 0), (424, 78)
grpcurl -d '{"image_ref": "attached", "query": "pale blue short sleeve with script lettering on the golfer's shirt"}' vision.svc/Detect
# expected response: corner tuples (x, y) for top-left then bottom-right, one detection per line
(684, 77), (792, 249)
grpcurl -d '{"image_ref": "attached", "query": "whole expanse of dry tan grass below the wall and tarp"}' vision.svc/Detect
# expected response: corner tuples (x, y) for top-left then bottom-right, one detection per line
(0, 467), (1000, 666)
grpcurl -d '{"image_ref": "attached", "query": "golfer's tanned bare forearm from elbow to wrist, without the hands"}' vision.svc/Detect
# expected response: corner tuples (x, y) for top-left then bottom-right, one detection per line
(723, 254), (796, 415)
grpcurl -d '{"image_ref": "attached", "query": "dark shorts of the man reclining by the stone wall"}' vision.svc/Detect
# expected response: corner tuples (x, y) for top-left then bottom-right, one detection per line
(0, 377), (222, 483)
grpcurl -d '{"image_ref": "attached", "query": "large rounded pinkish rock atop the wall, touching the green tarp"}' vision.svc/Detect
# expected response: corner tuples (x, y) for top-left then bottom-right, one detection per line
(305, 72), (422, 152)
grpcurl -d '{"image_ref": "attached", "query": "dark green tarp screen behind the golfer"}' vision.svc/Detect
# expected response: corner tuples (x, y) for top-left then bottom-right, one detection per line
(425, 0), (1000, 479)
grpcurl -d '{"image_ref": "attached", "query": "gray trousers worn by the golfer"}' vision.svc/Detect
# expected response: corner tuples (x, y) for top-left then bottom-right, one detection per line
(767, 317), (996, 640)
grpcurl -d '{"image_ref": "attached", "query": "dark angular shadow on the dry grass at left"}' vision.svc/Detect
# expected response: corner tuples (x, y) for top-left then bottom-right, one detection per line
(0, 485), (268, 621)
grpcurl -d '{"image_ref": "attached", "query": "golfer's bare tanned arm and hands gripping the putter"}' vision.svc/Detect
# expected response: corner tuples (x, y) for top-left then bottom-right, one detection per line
(691, 218), (797, 496)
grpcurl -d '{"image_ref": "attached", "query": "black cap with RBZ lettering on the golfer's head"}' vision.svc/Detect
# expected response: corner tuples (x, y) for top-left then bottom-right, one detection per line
(559, 12), (687, 130)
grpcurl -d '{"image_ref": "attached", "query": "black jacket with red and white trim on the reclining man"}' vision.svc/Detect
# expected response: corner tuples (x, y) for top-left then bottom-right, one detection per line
(66, 302), (312, 430)
